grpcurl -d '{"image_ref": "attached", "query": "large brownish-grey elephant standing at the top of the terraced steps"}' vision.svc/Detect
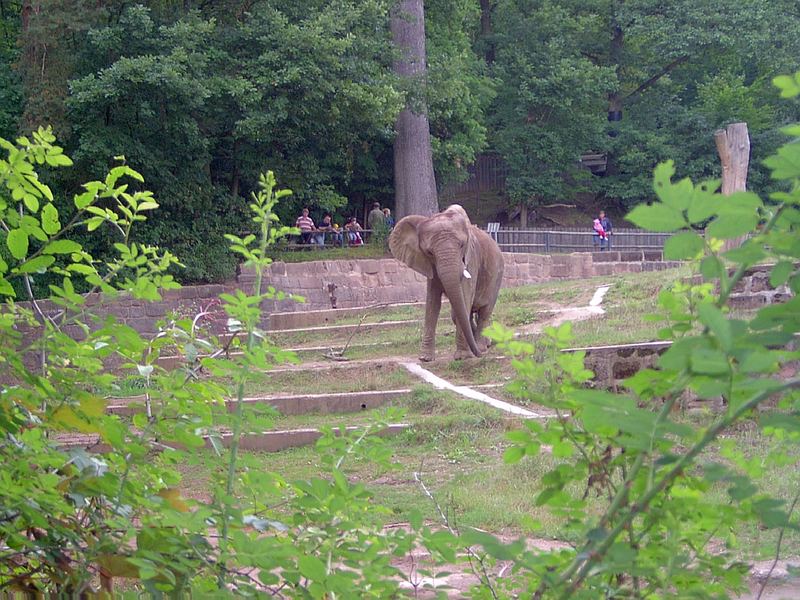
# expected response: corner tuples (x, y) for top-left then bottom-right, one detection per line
(389, 204), (503, 361)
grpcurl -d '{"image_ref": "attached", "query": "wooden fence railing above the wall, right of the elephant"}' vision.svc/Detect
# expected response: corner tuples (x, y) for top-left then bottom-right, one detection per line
(487, 223), (672, 254)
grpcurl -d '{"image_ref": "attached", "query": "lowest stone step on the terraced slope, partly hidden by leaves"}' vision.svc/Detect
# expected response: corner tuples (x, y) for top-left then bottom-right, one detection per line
(54, 423), (410, 453)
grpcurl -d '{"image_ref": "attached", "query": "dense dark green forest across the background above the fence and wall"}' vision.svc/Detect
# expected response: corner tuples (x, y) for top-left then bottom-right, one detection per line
(0, 0), (800, 281)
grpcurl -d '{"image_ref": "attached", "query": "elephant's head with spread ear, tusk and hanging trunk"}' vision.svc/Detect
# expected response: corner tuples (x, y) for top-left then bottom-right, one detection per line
(389, 204), (480, 356)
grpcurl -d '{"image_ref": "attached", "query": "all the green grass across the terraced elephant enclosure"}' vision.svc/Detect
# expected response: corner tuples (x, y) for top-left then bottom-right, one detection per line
(164, 270), (800, 576)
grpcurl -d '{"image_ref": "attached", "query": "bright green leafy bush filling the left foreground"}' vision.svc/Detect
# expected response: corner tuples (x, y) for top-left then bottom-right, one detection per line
(0, 137), (422, 598)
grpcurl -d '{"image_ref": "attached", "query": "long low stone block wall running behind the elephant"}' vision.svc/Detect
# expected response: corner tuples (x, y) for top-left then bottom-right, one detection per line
(12, 251), (790, 335)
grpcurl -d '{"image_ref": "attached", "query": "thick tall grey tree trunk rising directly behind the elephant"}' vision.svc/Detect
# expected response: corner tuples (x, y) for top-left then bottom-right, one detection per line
(391, 0), (439, 220)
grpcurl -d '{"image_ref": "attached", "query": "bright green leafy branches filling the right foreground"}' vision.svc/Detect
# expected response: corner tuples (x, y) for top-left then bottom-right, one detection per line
(456, 74), (800, 598)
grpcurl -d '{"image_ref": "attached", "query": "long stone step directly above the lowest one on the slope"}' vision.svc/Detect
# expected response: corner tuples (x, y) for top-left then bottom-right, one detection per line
(106, 388), (411, 415)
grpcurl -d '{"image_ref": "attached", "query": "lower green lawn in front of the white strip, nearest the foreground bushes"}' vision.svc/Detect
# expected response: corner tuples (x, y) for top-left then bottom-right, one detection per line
(173, 386), (800, 560)
